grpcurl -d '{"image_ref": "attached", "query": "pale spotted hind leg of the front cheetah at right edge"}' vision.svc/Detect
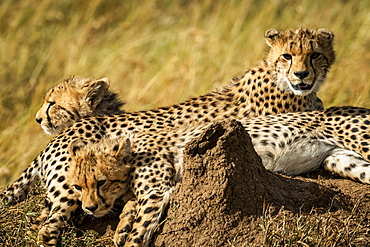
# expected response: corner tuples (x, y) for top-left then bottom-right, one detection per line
(324, 148), (370, 184)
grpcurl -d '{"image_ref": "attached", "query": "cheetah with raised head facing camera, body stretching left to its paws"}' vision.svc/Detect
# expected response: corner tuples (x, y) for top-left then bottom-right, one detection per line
(0, 29), (334, 246)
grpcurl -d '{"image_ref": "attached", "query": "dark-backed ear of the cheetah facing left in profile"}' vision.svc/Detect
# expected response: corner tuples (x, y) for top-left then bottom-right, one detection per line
(85, 78), (109, 108)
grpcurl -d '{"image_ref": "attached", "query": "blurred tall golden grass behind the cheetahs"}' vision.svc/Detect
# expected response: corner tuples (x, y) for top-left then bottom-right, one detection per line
(0, 0), (370, 186)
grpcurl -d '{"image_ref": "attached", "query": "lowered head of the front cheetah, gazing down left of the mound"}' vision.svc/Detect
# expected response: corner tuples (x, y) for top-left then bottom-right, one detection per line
(68, 138), (131, 217)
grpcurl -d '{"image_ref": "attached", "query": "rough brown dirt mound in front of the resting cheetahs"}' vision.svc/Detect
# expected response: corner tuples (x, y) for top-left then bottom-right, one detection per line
(153, 121), (368, 247)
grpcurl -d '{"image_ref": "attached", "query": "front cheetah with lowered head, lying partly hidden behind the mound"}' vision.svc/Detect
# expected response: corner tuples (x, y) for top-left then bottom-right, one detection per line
(67, 107), (370, 246)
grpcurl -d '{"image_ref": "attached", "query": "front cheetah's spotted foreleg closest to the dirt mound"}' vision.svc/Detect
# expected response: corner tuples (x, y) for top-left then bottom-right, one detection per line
(124, 190), (171, 247)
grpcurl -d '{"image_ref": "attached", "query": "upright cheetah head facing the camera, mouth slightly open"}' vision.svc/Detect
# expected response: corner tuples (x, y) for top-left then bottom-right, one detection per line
(265, 28), (335, 96)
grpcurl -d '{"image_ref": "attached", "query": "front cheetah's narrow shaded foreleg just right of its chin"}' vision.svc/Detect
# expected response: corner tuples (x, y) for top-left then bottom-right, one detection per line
(114, 198), (137, 246)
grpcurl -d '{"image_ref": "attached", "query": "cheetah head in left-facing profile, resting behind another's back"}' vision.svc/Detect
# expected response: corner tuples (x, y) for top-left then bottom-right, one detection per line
(36, 76), (123, 135)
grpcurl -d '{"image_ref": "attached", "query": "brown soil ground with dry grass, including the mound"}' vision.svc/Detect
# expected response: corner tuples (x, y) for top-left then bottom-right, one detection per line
(0, 121), (370, 247)
